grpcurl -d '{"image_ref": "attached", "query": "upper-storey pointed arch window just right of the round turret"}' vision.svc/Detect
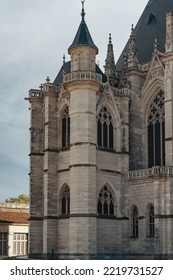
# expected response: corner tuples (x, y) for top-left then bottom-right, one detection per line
(97, 107), (114, 149)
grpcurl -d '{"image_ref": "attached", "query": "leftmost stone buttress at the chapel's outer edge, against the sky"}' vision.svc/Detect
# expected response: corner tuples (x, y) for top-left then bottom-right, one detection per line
(28, 90), (44, 257)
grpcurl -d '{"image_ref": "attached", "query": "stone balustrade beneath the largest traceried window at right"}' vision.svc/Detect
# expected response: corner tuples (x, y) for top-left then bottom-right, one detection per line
(128, 166), (173, 179)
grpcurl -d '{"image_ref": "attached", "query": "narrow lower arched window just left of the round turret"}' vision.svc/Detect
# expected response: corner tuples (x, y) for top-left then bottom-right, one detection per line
(61, 185), (70, 215)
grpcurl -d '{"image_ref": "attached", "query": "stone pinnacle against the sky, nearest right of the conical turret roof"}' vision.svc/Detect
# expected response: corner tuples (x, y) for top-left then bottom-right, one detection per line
(105, 34), (116, 77)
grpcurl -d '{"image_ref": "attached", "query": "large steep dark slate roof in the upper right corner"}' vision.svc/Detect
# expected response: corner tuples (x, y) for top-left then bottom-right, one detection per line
(116, 0), (173, 70)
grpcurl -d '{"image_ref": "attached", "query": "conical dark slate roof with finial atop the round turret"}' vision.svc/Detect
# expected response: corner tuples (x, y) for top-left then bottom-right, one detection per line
(69, 1), (97, 49)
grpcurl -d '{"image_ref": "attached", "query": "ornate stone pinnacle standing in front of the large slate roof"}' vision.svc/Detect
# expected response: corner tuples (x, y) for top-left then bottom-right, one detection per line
(127, 24), (138, 67)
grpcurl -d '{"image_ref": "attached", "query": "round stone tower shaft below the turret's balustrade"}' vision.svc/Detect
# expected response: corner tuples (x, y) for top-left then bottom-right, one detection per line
(64, 80), (99, 258)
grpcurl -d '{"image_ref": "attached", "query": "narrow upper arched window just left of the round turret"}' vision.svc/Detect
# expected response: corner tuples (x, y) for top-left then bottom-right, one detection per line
(62, 106), (70, 148)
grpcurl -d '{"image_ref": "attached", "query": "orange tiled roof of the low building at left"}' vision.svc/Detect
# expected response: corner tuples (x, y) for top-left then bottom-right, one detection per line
(0, 212), (29, 223)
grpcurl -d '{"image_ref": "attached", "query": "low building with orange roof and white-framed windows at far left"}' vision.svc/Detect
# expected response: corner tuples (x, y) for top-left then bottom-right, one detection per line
(0, 202), (29, 258)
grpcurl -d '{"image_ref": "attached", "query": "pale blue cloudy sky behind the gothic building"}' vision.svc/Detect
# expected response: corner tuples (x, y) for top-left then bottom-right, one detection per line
(0, 0), (148, 201)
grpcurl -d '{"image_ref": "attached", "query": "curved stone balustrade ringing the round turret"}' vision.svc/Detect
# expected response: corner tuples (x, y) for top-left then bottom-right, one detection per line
(63, 71), (102, 83)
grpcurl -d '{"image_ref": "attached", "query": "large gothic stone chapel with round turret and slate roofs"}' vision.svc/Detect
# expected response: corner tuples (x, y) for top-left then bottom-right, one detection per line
(27, 0), (173, 259)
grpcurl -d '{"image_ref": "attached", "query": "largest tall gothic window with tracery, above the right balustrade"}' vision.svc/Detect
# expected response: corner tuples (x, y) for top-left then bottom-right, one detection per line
(148, 91), (165, 167)
